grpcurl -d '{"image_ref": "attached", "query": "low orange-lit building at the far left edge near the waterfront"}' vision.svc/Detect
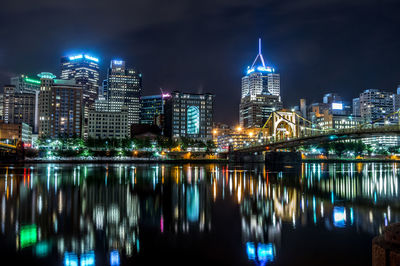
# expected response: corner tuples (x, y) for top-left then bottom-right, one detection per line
(0, 123), (32, 144)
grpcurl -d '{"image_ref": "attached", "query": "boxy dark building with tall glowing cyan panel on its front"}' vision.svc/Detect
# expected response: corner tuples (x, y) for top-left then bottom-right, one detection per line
(164, 91), (214, 140)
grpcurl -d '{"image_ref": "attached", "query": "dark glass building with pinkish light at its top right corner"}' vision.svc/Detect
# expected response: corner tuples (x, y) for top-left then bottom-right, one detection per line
(140, 94), (171, 127)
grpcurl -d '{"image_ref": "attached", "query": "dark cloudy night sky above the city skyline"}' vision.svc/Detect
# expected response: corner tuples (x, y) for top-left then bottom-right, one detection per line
(0, 0), (400, 124)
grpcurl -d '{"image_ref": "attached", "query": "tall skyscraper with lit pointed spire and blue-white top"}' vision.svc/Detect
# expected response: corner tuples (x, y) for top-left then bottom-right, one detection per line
(239, 39), (282, 127)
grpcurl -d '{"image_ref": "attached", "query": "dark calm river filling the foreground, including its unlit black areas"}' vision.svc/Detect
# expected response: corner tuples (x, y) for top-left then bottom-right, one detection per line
(0, 163), (400, 266)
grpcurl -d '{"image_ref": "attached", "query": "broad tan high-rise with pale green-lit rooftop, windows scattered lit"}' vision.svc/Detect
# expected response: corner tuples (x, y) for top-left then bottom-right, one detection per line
(39, 72), (83, 137)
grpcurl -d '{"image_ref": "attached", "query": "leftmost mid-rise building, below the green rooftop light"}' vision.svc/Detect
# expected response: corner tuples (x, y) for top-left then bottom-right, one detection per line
(2, 85), (39, 132)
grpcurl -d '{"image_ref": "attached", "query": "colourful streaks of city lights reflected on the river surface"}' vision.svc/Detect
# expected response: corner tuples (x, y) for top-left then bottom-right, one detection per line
(0, 163), (400, 265)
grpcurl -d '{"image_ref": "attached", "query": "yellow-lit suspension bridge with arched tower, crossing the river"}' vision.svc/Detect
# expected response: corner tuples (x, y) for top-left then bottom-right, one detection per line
(234, 110), (400, 153)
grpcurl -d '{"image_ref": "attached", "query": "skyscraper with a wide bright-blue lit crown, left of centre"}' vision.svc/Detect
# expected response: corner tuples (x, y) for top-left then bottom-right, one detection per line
(60, 54), (99, 106)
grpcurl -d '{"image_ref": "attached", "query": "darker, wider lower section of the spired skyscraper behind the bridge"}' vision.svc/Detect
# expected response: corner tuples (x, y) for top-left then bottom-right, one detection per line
(239, 94), (283, 128)
